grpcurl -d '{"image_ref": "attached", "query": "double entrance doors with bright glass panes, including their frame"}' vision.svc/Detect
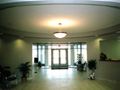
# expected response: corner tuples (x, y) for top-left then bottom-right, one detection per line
(51, 49), (68, 69)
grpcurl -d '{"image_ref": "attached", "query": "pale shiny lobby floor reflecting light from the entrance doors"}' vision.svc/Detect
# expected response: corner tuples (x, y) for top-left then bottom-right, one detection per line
(11, 68), (120, 90)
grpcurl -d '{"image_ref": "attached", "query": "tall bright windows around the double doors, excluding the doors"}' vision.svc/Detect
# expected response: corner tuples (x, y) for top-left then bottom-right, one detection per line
(32, 43), (87, 66)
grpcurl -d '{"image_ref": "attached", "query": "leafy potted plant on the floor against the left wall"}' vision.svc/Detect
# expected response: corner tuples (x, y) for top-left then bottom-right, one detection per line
(18, 62), (31, 82)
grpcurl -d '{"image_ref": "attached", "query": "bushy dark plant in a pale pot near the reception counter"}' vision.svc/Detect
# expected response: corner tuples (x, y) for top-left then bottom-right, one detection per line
(88, 60), (96, 80)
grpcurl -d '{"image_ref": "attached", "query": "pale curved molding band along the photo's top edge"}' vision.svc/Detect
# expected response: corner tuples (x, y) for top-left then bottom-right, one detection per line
(0, 0), (120, 9)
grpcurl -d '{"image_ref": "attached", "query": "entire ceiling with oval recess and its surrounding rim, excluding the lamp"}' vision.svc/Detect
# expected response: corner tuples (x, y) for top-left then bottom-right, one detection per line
(0, 0), (120, 39)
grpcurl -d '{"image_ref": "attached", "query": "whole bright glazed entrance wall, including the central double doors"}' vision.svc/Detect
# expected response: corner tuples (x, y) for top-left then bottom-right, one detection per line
(32, 43), (87, 69)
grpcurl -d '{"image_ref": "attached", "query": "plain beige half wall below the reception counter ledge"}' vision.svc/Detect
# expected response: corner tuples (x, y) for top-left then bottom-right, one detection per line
(97, 61), (120, 82)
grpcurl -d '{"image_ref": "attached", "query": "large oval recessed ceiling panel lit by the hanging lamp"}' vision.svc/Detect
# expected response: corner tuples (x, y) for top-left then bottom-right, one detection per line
(0, 5), (120, 34)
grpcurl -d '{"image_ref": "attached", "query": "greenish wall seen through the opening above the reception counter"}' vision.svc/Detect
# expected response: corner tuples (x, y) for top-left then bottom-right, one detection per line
(100, 38), (120, 60)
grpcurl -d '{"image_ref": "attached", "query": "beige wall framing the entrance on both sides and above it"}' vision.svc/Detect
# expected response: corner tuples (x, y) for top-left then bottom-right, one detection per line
(0, 36), (118, 82)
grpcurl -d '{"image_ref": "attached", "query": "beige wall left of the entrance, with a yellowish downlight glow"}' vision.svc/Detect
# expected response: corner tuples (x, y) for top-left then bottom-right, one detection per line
(0, 37), (32, 70)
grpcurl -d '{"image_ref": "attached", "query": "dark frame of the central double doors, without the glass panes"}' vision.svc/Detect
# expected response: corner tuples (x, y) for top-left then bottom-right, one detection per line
(51, 48), (68, 69)
